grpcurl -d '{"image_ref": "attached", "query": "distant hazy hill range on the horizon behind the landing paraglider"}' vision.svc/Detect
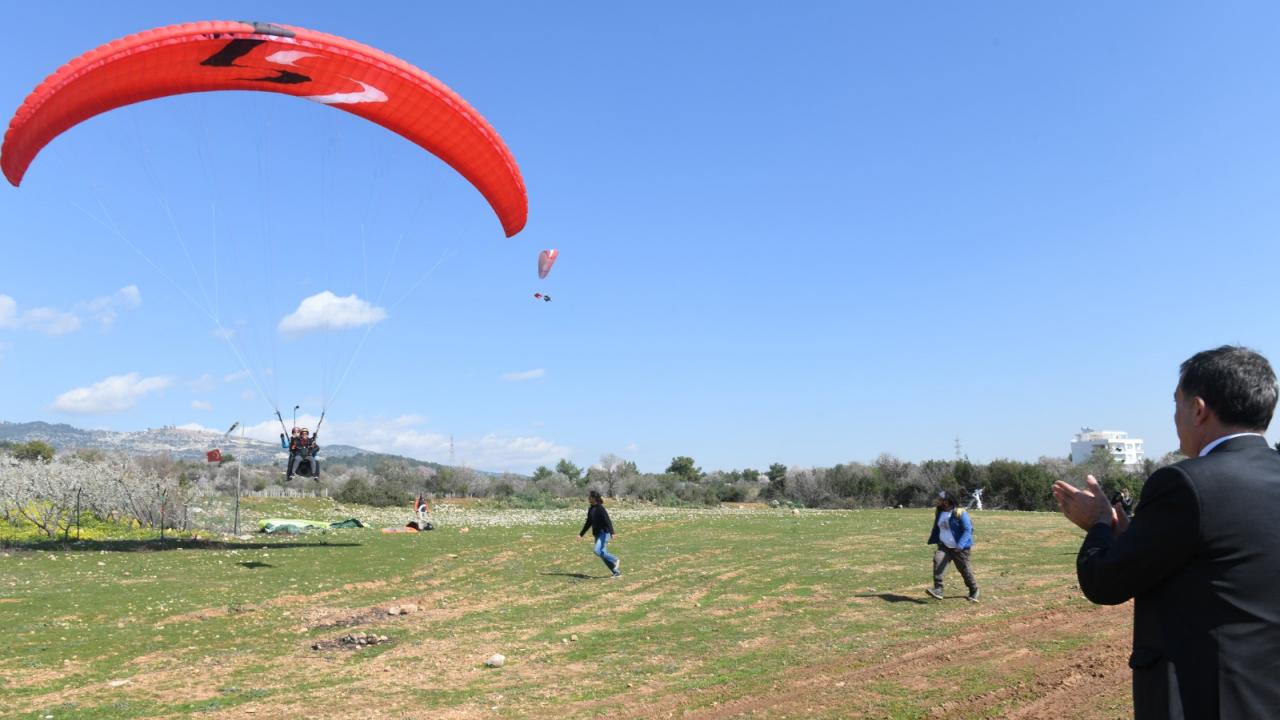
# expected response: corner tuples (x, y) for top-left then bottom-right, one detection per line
(0, 420), (455, 469)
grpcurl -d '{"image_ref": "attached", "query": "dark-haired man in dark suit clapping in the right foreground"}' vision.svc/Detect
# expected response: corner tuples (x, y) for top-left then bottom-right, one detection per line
(1053, 346), (1280, 720)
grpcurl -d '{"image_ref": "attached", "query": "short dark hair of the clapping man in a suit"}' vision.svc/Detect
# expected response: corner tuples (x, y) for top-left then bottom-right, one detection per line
(1178, 345), (1277, 430)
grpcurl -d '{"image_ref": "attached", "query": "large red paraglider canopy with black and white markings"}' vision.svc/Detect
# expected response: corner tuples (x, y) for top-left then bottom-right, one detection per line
(0, 22), (529, 237)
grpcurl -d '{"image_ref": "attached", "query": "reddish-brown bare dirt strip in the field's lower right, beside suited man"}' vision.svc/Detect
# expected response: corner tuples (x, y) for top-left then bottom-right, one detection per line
(593, 606), (1132, 720)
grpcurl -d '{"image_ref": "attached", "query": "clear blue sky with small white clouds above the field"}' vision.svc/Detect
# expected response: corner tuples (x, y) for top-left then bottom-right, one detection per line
(0, 1), (1280, 471)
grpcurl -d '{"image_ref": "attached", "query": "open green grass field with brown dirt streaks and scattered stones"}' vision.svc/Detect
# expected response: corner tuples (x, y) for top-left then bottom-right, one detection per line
(0, 501), (1132, 720)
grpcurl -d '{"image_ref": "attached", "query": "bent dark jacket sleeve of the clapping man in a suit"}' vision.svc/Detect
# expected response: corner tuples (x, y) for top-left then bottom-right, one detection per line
(1075, 466), (1199, 605)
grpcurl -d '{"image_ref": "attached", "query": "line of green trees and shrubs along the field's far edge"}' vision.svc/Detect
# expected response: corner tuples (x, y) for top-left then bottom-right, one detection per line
(0, 441), (1181, 510)
